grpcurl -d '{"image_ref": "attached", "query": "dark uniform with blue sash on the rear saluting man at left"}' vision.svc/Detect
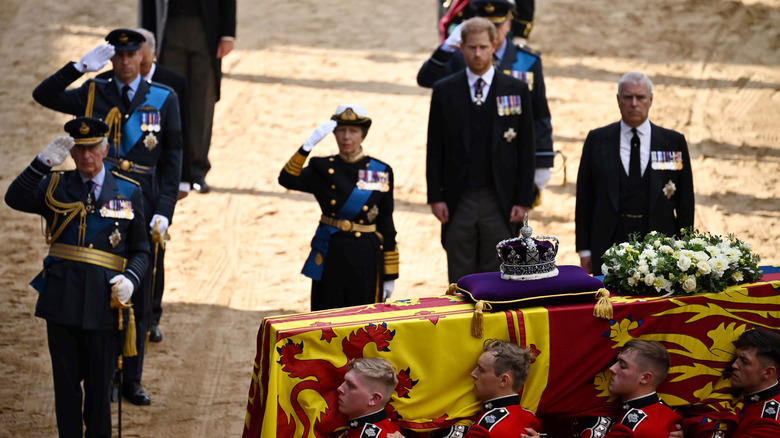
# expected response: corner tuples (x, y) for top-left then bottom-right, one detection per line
(33, 31), (182, 404)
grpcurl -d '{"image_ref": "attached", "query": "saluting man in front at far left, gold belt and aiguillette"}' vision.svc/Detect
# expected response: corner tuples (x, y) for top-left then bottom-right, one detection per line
(5, 117), (150, 438)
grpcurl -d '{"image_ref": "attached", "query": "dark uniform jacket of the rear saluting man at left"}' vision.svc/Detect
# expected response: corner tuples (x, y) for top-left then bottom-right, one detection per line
(33, 63), (182, 223)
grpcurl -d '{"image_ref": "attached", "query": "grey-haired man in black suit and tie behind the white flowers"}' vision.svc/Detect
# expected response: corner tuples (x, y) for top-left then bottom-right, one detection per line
(575, 72), (694, 275)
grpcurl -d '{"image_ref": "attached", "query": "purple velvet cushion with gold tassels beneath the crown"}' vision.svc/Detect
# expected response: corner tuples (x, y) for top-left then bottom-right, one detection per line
(458, 266), (604, 308)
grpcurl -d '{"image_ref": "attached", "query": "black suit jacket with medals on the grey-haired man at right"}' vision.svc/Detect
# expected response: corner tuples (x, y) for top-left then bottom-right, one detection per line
(575, 122), (694, 272)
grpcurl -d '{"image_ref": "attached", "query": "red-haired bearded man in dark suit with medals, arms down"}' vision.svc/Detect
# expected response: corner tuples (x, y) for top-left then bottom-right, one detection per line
(426, 17), (534, 282)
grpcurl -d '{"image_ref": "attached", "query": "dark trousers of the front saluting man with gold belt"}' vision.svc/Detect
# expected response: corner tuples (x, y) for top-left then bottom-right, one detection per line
(46, 321), (118, 438)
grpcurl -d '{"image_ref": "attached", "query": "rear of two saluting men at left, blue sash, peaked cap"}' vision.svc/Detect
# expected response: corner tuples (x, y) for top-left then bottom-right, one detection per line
(33, 29), (182, 405)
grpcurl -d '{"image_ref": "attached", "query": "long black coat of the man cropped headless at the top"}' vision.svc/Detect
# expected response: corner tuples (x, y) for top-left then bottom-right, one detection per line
(138, 0), (236, 100)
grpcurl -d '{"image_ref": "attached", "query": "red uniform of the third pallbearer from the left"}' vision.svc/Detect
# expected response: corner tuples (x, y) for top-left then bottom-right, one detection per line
(607, 393), (682, 438)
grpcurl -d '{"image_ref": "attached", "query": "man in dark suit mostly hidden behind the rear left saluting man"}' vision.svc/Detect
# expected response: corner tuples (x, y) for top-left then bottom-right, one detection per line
(97, 28), (191, 342)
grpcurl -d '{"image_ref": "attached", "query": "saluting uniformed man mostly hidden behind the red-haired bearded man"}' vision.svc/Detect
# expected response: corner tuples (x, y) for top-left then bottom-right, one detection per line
(417, 0), (555, 196)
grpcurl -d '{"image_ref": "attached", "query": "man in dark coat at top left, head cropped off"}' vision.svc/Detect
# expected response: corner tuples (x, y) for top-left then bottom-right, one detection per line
(139, 0), (236, 193)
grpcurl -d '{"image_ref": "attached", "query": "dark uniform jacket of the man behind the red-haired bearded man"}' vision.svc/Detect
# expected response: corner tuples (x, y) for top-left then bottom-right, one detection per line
(417, 41), (555, 168)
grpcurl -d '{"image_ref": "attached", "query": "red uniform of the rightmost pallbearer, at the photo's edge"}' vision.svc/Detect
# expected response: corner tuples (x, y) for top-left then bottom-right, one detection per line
(731, 383), (780, 438)
